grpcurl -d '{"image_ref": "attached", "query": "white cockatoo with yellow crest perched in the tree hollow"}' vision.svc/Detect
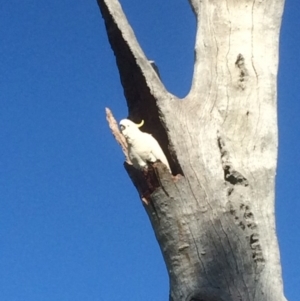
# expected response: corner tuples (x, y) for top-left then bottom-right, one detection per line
(120, 119), (171, 173)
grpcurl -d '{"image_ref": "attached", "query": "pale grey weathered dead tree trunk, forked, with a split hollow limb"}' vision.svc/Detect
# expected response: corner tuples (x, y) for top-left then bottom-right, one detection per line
(98, 0), (286, 301)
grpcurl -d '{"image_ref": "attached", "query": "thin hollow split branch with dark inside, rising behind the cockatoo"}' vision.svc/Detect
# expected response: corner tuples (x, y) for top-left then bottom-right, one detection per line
(98, 0), (182, 175)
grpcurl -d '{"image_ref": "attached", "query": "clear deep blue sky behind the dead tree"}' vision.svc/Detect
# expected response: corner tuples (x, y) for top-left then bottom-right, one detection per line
(0, 0), (300, 301)
